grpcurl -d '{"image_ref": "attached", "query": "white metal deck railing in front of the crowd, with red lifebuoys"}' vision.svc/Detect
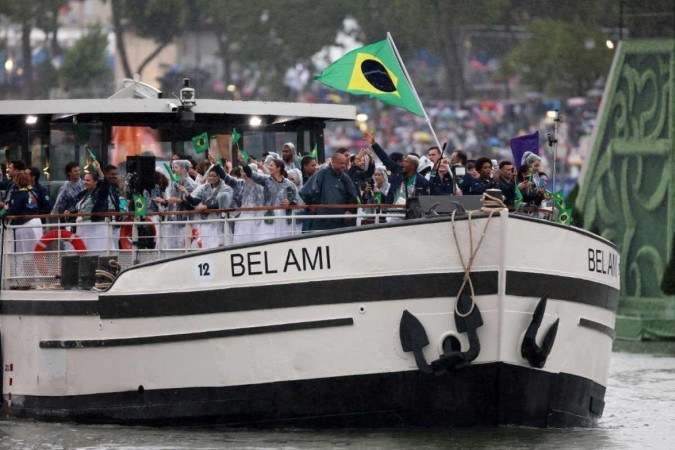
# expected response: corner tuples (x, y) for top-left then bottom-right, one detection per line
(0, 205), (403, 289)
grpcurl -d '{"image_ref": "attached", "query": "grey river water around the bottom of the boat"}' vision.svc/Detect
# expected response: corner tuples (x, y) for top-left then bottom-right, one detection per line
(0, 343), (675, 450)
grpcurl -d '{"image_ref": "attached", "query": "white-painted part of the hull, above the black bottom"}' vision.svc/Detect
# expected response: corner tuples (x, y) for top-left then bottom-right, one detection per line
(0, 213), (619, 428)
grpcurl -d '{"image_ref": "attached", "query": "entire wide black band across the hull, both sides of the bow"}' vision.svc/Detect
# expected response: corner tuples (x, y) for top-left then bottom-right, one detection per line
(0, 271), (619, 319)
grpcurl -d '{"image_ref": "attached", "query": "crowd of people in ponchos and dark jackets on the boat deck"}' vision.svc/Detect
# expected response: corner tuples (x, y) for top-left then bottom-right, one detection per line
(0, 132), (547, 252)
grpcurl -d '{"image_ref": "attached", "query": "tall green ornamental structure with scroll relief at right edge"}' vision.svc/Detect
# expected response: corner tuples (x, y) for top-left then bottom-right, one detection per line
(576, 39), (675, 339)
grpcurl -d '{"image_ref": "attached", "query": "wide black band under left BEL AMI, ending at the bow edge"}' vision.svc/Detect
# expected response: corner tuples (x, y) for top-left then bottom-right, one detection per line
(99, 271), (498, 319)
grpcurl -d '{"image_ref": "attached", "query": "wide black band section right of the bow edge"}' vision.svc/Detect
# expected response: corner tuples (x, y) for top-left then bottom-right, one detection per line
(506, 270), (619, 313)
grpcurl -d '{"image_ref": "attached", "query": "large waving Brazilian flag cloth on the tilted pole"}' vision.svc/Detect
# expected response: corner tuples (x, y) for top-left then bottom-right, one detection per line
(314, 39), (424, 116)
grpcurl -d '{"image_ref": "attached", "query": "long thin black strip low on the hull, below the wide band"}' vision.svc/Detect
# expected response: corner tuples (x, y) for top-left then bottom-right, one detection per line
(40, 317), (354, 349)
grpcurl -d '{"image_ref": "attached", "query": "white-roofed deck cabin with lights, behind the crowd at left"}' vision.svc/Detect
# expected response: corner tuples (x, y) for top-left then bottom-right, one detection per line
(0, 98), (356, 198)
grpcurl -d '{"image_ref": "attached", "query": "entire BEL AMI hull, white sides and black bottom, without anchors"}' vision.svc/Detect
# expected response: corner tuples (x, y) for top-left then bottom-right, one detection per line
(0, 213), (619, 426)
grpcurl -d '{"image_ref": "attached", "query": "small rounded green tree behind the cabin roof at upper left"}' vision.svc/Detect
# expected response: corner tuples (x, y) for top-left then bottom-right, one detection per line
(59, 25), (113, 97)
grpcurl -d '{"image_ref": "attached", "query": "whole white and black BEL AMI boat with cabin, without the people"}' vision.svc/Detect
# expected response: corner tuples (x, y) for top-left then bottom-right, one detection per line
(0, 79), (620, 428)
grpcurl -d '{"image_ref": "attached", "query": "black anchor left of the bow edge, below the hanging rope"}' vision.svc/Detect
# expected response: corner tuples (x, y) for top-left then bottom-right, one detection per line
(399, 294), (483, 375)
